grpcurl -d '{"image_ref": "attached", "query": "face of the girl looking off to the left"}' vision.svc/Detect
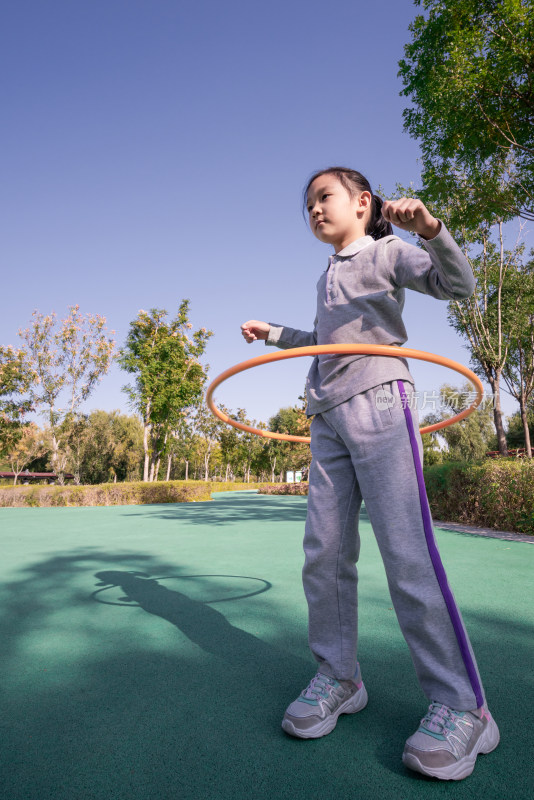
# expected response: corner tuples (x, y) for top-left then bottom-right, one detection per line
(307, 174), (371, 253)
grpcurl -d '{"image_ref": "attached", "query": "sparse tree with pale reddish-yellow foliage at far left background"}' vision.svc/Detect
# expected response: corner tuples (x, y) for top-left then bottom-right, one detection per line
(19, 305), (115, 483)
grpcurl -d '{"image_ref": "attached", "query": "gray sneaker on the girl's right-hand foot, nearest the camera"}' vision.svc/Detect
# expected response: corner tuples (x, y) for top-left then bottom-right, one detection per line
(402, 703), (500, 781)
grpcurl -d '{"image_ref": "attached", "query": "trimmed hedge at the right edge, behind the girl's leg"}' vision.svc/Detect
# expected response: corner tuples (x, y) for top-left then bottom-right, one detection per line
(425, 458), (534, 535)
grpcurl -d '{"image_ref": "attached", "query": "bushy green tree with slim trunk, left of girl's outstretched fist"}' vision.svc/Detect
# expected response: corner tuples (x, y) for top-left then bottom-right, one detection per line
(119, 300), (213, 481)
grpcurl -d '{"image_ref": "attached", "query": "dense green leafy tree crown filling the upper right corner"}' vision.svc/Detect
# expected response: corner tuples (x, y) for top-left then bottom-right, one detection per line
(399, 0), (534, 225)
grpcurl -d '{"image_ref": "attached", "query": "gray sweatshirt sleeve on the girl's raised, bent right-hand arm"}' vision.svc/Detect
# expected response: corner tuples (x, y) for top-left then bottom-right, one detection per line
(391, 222), (476, 300)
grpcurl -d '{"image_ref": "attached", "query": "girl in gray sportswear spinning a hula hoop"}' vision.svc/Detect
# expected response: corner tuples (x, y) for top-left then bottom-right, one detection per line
(241, 167), (499, 780)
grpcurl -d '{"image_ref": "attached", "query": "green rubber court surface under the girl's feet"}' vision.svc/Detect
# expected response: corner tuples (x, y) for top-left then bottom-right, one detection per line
(0, 493), (534, 800)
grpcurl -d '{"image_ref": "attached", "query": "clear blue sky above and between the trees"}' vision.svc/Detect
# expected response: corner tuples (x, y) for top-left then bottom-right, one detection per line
(0, 0), (528, 420)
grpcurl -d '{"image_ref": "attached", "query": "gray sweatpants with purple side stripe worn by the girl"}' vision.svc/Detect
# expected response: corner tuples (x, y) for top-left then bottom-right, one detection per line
(303, 381), (484, 710)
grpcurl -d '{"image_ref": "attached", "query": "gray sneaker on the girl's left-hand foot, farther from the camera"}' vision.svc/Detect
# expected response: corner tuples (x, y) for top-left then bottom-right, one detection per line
(282, 672), (367, 739)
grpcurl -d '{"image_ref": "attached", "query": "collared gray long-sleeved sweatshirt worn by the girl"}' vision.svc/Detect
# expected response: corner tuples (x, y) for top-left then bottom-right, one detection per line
(265, 223), (475, 416)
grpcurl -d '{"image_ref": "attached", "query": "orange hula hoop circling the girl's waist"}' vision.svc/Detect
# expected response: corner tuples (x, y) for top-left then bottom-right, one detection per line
(206, 344), (484, 444)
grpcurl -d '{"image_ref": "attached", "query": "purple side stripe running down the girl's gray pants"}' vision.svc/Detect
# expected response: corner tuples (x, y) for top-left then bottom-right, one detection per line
(397, 380), (484, 710)
